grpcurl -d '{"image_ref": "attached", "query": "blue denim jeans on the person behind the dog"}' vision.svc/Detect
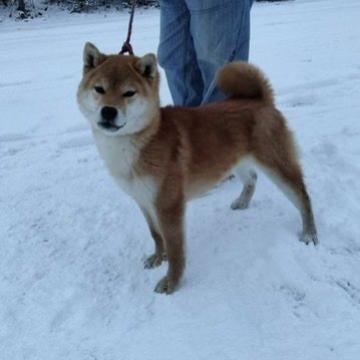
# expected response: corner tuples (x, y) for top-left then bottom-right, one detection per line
(158, 0), (253, 106)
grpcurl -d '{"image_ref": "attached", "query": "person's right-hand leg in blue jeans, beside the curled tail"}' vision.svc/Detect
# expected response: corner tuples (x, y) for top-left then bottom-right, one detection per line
(185, 0), (253, 103)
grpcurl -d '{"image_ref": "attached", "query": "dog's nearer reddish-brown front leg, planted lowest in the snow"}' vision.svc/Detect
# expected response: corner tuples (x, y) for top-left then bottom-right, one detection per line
(155, 199), (185, 294)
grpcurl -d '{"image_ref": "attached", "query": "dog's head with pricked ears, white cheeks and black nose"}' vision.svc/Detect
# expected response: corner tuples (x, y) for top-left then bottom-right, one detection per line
(77, 43), (159, 136)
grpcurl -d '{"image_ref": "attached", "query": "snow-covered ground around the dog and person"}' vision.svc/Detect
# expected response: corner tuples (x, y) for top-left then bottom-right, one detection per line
(0, 0), (360, 360)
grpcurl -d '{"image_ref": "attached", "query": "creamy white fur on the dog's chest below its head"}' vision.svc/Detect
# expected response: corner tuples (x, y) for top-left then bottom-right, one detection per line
(94, 131), (156, 211)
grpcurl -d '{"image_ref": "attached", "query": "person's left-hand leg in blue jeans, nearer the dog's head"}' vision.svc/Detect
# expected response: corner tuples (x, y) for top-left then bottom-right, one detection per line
(158, 0), (203, 106)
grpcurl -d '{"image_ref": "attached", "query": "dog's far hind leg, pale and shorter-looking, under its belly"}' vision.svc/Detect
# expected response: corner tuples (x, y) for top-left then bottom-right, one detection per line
(231, 164), (257, 210)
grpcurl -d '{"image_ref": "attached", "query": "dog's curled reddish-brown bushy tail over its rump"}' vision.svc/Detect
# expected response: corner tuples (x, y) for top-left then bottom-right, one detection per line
(217, 61), (274, 104)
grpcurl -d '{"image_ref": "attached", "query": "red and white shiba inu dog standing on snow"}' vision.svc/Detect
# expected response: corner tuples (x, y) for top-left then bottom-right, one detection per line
(77, 43), (318, 294)
